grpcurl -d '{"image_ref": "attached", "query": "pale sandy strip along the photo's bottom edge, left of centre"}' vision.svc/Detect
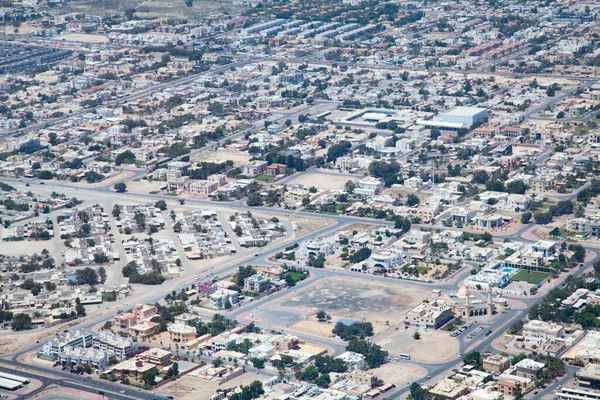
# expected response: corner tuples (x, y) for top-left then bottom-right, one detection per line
(156, 373), (268, 400)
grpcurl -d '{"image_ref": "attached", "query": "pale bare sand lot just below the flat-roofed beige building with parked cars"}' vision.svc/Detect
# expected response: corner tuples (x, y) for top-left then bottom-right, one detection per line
(374, 327), (458, 363)
